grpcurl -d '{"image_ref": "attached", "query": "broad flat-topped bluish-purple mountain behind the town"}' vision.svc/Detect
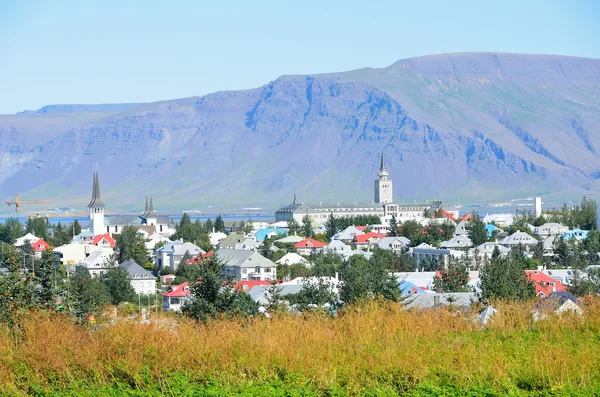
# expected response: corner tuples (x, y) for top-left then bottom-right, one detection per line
(0, 53), (600, 210)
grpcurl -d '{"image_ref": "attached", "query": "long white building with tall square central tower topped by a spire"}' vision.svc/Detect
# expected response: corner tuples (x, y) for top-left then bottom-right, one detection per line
(275, 153), (442, 225)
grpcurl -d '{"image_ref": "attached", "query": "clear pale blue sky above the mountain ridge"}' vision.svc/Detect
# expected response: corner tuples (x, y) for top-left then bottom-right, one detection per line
(0, 0), (600, 114)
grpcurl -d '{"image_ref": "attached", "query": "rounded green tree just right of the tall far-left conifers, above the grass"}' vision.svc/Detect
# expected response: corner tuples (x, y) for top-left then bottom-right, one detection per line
(69, 270), (111, 316)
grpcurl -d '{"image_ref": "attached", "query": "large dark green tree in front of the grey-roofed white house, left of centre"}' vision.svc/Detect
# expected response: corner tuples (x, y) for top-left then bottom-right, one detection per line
(182, 255), (258, 321)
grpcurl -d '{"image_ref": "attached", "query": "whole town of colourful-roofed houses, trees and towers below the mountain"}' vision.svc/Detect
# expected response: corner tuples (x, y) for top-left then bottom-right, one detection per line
(0, 153), (600, 321)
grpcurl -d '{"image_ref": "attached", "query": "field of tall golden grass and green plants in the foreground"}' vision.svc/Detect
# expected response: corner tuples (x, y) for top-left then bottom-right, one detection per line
(0, 302), (600, 396)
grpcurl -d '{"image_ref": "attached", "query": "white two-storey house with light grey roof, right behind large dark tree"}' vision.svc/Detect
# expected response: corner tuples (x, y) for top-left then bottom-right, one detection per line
(216, 248), (277, 280)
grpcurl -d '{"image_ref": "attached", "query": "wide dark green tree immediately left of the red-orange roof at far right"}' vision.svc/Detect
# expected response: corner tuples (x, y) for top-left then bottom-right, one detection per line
(479, 247), (535, 302)
